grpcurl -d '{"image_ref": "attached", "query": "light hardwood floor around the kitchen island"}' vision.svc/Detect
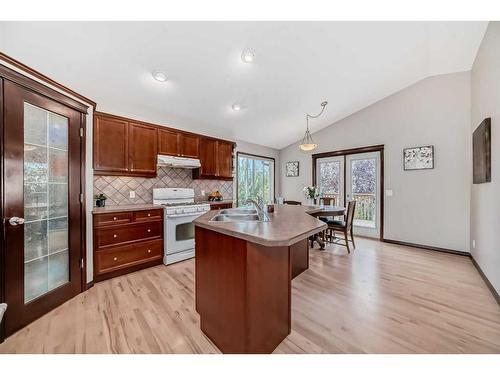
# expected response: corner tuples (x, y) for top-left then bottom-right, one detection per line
(0, 238), (500, 353)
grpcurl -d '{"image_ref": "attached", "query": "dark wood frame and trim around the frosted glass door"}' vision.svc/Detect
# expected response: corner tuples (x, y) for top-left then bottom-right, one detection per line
(0, 64), (88, 343)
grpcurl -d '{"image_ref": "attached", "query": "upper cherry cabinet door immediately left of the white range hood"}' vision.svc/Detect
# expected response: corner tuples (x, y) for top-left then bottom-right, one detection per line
(128, 122), (158, 175)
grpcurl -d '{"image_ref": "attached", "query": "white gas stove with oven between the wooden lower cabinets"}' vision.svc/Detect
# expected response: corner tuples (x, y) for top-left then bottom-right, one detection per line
(153, 188), (210, 264)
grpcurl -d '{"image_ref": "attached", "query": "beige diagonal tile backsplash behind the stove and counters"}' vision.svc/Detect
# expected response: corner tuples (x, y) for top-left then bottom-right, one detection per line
(94, 167), (233, 206)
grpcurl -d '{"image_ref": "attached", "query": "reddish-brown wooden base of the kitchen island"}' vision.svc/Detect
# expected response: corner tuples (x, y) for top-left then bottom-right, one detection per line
(195, 226), (309, 353)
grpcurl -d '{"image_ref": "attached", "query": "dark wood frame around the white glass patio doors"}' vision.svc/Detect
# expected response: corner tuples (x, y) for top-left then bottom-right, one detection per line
(312, 145), (384, 241)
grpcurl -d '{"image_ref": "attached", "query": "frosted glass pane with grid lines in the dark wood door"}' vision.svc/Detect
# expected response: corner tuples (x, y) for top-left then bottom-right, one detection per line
(23, 103), (69, 303)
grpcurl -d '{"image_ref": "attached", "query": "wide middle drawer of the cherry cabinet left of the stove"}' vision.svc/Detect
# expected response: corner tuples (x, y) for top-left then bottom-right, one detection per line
(94, 221), (163, 248)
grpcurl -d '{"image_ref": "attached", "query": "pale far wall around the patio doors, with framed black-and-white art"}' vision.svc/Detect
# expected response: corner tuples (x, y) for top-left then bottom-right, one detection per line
(280, 72), (471, 251)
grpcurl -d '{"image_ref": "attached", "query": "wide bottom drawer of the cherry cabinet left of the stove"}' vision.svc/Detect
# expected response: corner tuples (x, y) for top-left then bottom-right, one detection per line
(94, 240), (163, 275)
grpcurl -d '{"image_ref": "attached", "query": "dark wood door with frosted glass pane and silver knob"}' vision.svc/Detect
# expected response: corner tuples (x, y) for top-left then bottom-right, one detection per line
(0, 79), (83, 336)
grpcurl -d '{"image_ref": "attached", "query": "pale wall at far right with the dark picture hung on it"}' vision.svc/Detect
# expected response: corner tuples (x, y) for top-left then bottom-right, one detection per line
(470, 22), (500, 293)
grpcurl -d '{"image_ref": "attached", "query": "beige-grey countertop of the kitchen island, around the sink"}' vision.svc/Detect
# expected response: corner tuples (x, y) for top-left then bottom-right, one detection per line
(194, 205), (327, 246)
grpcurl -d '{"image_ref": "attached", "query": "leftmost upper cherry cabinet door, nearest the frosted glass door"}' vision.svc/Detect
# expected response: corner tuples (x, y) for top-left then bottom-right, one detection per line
(94, 115), (128, 174)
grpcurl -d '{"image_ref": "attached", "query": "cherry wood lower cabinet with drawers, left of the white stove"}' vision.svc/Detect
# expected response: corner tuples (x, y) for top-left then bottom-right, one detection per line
(94, 209), (163, 281)
